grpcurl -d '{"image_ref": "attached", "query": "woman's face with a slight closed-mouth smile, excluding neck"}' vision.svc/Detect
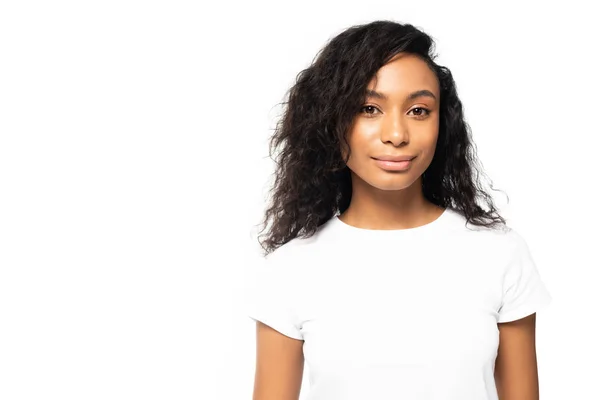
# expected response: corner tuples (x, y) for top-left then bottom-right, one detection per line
(347, 53), (440, 191)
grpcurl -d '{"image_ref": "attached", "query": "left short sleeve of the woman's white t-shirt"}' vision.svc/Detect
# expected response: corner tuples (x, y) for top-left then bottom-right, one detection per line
(244, 256), (303, 340)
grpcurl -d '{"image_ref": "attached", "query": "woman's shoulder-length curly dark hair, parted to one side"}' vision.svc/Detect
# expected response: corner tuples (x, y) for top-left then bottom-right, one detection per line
(259, 20), (506, 255)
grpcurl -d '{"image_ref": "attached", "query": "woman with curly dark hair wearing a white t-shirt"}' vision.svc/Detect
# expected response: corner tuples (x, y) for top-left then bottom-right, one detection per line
(247, 21), (551, 400)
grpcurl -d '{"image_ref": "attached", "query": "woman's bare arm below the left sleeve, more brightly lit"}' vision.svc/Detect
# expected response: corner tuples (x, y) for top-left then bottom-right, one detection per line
(252, 321), (304, 400)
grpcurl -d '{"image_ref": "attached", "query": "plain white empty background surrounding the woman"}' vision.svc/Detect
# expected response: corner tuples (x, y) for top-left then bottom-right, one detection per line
(0, 1), (600, 400)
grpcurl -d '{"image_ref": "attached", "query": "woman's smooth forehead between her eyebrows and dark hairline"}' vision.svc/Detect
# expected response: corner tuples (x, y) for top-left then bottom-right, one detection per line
(368, 53), (439, 98)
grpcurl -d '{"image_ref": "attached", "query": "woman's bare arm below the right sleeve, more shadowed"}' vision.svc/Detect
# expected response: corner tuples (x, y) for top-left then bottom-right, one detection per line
(494, 313), (540, 400)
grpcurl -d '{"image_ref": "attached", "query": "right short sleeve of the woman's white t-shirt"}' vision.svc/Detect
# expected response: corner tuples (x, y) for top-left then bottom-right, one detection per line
(498, 229), (552, 322)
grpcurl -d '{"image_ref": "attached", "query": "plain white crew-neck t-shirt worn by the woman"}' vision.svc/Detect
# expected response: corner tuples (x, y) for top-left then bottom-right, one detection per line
(244, 208), (551, 400)
